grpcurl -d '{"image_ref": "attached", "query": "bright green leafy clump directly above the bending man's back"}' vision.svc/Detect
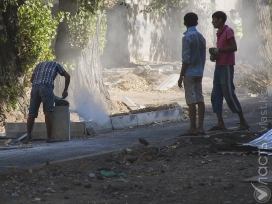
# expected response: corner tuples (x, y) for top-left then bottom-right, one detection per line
(17, 0), (58, 71)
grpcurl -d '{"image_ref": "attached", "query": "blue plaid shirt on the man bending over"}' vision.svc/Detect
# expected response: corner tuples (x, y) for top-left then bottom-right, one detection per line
(32, 61), (65, 86)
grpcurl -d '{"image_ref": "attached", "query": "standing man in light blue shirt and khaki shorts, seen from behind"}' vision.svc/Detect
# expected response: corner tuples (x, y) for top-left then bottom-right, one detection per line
(178, 12), (206, 136)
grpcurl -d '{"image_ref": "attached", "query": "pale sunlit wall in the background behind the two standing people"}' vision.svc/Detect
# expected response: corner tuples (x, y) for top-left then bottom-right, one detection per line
(101, 0), (241, 68)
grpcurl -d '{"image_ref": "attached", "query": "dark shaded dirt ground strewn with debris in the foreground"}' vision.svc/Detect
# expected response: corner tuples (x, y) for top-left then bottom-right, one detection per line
(0, 132), (270, 204)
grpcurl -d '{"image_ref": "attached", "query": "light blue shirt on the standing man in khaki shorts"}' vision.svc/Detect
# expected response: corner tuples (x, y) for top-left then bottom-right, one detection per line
(182, 26), (206, 77)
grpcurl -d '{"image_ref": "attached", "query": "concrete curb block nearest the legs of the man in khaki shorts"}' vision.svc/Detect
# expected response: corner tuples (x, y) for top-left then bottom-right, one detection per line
(137, 108), (183, 125)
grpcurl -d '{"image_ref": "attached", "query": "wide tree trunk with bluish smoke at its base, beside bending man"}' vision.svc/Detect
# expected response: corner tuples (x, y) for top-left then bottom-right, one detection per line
(56, 0), (110, 123)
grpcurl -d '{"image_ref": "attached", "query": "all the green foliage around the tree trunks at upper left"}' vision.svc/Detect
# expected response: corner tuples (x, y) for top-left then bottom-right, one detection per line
(0, 0), (109, 110)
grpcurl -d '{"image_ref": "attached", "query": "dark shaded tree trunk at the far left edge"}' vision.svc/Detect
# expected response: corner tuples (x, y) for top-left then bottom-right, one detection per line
(0, 2), (27, 115)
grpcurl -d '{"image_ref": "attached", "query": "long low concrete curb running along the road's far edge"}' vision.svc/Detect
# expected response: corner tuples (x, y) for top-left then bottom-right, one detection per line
(5, 107), (183, 139)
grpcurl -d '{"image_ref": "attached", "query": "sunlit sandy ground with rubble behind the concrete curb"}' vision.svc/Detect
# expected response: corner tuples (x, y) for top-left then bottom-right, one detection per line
(0, 61), (266, 133)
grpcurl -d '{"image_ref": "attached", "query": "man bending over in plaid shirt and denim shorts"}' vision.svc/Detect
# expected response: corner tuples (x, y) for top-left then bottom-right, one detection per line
(27, 61), (70, 143)
